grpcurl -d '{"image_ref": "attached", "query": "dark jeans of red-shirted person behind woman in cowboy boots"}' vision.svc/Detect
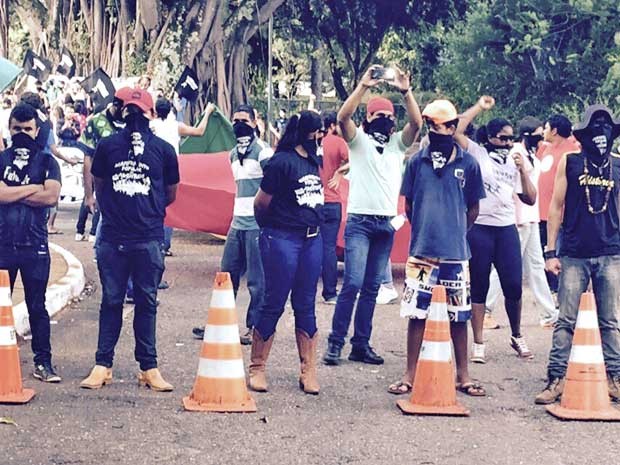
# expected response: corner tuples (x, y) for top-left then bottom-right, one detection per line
(321, 202), (342, 300)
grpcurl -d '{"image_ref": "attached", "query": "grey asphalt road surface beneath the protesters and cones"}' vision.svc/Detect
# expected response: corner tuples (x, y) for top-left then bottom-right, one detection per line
(0, 206), (620, 465)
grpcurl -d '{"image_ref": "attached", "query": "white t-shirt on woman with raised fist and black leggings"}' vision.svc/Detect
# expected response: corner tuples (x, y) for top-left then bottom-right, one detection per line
(467, 139), (523, 226)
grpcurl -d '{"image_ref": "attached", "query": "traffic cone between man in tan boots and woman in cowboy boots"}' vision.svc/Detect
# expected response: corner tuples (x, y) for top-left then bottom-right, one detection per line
(183, 273), (256, 412)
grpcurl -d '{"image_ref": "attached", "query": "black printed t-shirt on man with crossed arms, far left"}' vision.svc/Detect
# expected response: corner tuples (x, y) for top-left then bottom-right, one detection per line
(0, 147), (61, 247)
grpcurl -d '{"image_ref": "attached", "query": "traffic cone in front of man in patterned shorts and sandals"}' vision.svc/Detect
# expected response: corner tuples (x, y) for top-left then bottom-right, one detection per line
(396, 285), (469, 416)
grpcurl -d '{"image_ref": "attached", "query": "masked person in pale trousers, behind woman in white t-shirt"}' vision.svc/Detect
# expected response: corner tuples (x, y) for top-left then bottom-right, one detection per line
(485, 116), (558, 328)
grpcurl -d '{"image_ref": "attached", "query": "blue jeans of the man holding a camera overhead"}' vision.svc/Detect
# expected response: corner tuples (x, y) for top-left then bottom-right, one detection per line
(329, 214), (394, 349)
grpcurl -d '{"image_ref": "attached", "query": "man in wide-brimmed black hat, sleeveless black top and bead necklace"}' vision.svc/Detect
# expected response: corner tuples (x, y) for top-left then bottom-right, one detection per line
(536, 104), (620, 404)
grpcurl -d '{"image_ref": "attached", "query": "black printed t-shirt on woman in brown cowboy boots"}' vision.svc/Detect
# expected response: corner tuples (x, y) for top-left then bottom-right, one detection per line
(259, 150), (324, 231)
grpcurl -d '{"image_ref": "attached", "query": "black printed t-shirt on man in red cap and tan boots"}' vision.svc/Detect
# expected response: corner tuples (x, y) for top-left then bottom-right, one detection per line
(91, 129), (179, 244)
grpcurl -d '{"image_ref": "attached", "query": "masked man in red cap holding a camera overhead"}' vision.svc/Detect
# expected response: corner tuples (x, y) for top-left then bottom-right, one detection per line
(323, 65), (422, 365)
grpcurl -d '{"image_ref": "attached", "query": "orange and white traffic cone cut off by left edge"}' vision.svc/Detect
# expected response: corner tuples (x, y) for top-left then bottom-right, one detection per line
(0, 270), (34, 404)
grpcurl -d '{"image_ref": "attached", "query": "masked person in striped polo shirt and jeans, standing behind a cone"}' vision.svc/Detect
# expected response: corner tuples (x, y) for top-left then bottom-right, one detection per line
(192, 105), (273, 345)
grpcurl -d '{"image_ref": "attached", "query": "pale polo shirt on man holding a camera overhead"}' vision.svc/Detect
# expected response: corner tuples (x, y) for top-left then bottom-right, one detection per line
(347, 128), (407, 216)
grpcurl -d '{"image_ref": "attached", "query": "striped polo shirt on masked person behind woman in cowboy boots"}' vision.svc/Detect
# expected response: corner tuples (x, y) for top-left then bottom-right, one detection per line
(230, 139), (273, 230)
